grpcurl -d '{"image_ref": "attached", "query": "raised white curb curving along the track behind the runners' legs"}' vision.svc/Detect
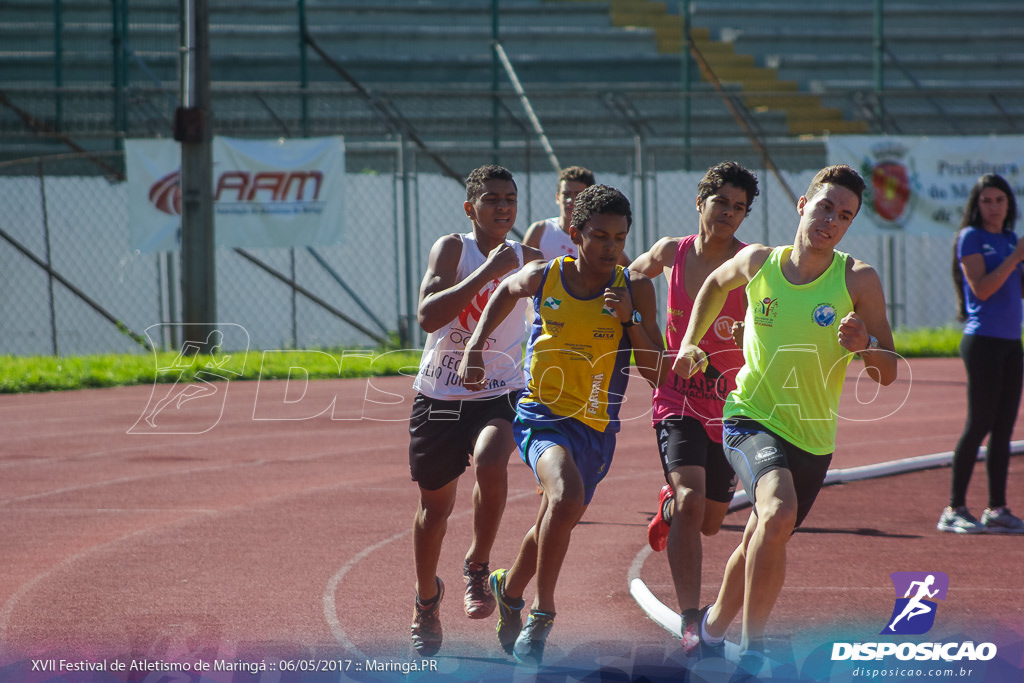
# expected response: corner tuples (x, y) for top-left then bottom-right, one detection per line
(626, 441), (1024, 659)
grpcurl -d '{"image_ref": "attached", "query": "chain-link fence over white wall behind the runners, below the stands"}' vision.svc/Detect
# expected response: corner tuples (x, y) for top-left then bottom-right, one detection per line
(0, 143), (954, 354)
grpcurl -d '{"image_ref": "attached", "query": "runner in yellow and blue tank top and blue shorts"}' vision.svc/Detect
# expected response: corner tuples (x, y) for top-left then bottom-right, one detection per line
(460, 185), (664, 666)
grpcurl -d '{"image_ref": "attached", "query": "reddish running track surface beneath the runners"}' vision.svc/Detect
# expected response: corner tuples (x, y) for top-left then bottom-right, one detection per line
(0, 359), (1024, 681)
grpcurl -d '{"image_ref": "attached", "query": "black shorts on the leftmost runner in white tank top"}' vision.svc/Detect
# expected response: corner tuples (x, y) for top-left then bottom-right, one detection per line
(409, 391), (517, 490)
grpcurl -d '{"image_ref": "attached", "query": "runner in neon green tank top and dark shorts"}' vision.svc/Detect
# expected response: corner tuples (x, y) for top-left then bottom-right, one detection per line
(673, 165), (898, 675)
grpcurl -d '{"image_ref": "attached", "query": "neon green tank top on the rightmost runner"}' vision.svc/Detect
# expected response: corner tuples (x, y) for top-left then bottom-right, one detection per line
(724, 247), (853, 456)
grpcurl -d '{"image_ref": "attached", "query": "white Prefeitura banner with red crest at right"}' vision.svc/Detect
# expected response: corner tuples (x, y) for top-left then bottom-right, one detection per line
(825, 135), (1024, 236)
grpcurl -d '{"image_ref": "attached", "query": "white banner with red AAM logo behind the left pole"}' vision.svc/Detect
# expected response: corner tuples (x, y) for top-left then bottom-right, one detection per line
(125, 137), (345, 252)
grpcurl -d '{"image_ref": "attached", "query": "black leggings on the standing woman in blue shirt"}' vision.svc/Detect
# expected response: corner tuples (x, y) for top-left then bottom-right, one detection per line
(949, 335), (1024, 508)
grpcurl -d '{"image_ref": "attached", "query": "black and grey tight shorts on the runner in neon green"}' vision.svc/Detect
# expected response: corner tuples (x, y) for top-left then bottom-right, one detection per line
(723, 418), (831, 526)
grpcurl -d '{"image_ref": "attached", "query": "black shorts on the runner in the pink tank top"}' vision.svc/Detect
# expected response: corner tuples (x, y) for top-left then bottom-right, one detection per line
(654, 415), (736, 503)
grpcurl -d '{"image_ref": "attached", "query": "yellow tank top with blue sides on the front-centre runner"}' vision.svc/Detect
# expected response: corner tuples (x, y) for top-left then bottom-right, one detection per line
(519, 256), (632, 432)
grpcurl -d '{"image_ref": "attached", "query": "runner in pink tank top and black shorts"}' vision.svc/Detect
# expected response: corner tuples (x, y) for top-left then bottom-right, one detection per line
(630, 162), (758, 655)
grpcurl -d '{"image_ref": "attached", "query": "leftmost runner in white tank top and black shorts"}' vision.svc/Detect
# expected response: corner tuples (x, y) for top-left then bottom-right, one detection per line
(409, 165), (541, 656)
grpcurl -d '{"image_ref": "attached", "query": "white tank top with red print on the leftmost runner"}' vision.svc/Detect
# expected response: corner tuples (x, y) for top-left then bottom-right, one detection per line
(413, 232), (526, 400)
